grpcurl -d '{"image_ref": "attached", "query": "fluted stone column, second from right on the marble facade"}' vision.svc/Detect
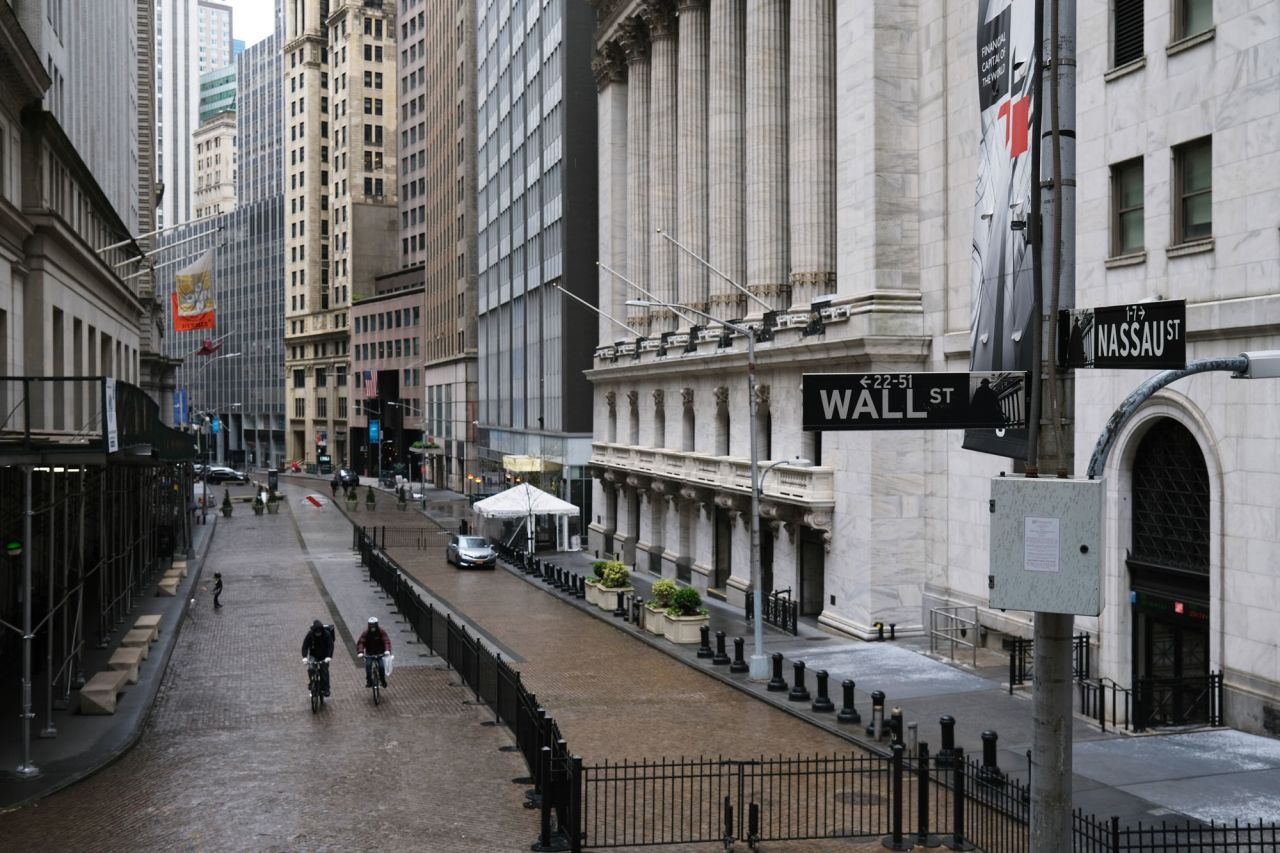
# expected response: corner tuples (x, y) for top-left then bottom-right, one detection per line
(746, 0), (791, 315)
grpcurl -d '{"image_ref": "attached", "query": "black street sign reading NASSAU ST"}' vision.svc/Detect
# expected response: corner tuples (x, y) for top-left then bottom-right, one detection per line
(1059, 300), (1187, 370)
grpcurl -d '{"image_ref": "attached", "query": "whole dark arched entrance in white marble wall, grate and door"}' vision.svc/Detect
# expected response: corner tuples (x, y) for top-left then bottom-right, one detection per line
(1126, 418), (1210, 727)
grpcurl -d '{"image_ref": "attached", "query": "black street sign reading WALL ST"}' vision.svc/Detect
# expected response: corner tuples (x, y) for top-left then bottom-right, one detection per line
(801, 371), (1029, 430)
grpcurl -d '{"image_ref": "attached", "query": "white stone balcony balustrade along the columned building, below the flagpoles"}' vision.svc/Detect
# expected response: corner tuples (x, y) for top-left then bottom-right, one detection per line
(591, 442), (836, 505)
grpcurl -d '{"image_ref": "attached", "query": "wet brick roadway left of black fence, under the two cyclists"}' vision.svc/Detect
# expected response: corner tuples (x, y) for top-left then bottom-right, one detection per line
(0, 485), (536, 852)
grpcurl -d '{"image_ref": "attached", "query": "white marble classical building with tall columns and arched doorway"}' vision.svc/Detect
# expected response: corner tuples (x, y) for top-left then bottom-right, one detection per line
(590, 0), (1280, 729)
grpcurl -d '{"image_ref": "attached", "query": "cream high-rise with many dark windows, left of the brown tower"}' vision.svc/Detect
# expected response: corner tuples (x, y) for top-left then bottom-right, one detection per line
(284, 0), (397, 461)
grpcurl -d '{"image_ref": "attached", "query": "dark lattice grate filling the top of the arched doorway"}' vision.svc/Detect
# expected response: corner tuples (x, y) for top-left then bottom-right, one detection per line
(1133, 419), (1210, 574)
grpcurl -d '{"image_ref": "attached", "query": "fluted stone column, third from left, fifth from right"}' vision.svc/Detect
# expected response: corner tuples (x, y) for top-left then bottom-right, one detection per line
(636, 0), (680, 333)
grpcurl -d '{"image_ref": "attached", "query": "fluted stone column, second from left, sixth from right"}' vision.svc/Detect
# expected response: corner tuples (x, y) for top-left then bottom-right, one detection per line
(614, 18), (653, 332)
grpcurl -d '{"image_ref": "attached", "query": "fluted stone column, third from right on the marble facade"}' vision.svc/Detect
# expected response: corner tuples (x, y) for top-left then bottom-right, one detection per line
(707, 0), (746, 313)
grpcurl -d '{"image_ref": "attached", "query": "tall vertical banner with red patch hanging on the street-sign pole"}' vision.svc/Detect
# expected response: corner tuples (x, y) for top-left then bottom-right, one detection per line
(964, 0), (1039, 459)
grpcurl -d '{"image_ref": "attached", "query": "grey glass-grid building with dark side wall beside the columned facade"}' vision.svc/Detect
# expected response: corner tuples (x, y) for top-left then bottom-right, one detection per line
(476, 0), (596, 525)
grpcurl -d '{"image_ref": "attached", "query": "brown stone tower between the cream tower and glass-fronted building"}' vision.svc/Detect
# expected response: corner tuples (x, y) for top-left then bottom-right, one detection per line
(397, 0), (476, 492)
